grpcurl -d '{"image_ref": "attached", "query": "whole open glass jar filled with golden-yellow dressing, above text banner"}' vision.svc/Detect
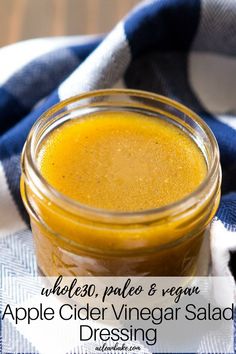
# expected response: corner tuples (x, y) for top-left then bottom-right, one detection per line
(21, 90), (221, 276)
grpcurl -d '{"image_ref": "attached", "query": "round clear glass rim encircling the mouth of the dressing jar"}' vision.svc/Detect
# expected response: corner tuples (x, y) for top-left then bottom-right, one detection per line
(21, 89), (219, 223)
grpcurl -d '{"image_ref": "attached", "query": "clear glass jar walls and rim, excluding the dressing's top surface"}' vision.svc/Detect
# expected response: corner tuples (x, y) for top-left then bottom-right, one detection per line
(21, 89), (221, 276)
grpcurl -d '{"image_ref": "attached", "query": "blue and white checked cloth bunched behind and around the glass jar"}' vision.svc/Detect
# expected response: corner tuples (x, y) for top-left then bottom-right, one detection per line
(0, 0), (236, 352)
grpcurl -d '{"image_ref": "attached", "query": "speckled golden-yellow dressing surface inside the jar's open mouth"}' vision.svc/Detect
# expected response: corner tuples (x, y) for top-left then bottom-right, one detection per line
(38, 111), (207, 211)
